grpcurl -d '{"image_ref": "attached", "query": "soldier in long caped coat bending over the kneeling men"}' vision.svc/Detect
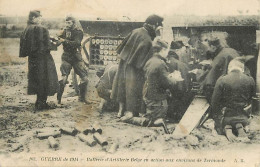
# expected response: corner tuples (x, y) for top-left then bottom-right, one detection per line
(111, 15), (163, 116)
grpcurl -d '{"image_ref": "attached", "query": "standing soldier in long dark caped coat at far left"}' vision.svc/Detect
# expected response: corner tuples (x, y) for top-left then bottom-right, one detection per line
(19, 10), (59, 110)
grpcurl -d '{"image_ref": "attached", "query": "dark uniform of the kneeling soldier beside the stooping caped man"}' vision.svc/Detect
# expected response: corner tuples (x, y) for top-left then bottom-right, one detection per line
(143, 54), (173, 122)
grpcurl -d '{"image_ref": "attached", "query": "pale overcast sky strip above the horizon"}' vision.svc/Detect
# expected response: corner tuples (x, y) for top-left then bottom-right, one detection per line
(0, 0), (260, 20)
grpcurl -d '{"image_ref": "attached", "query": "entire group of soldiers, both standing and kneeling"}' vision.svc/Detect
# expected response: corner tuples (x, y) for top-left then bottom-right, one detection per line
(20, 11), (255, 141)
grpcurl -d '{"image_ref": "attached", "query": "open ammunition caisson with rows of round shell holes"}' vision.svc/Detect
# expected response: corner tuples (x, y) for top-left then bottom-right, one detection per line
(72, 20), (144, 103)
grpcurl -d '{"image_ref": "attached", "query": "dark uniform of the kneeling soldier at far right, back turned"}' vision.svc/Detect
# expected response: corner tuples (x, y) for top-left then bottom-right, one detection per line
(211, 70), (255, 133)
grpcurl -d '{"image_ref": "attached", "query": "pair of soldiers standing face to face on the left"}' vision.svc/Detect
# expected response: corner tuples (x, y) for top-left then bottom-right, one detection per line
(19, 10), (88, 110)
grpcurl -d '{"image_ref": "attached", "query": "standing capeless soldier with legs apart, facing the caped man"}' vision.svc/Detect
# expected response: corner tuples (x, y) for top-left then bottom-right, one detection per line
(57, 16), (88, 104)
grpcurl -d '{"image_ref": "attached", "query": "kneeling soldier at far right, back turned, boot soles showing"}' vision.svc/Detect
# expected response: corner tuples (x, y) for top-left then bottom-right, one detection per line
(211, 57), (255, 142)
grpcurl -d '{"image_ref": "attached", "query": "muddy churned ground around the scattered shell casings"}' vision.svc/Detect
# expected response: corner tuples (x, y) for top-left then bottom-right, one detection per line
(0, 39), (260, 166)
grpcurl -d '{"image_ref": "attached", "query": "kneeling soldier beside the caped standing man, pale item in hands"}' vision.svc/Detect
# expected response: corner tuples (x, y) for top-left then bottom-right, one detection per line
(123, 38), (181, 126)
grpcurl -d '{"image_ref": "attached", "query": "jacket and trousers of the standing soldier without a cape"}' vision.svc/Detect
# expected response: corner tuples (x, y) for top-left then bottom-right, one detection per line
(59, 27), (88, 80)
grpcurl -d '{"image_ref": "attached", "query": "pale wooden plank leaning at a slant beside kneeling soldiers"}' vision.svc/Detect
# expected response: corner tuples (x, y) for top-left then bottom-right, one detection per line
(173, 96), (209, 138)
